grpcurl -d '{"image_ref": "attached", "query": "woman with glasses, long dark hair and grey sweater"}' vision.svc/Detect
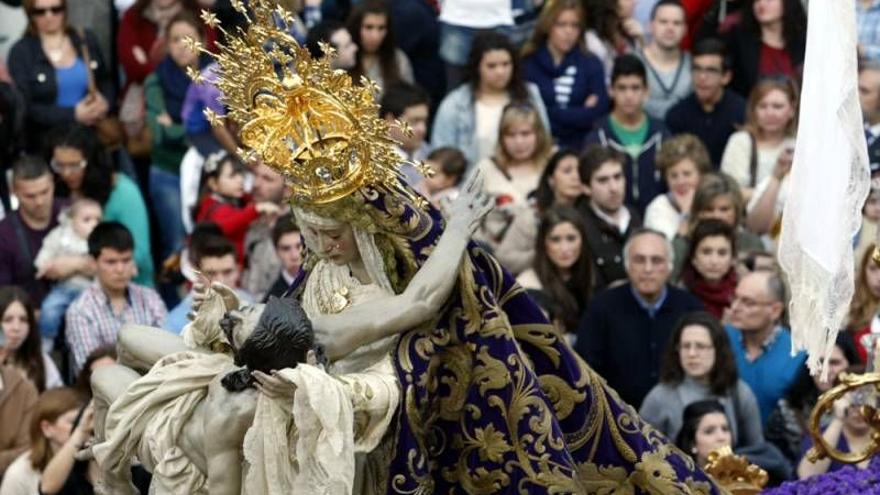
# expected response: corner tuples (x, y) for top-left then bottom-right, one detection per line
(639, 311), (764, 447)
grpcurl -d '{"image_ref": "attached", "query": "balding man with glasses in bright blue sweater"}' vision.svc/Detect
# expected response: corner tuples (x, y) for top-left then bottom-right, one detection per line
(726, 270), (806, 424)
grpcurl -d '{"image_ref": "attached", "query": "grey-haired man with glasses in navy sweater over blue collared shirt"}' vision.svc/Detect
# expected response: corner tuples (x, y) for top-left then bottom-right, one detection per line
(576, 229), (703, 408)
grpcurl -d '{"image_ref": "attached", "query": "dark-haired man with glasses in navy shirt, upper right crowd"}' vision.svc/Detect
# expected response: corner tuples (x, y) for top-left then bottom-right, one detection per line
(666, 38), (746, 168)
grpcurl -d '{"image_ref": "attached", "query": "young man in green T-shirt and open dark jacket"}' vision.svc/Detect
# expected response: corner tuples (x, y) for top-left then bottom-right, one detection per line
(586, 55), (669, 217)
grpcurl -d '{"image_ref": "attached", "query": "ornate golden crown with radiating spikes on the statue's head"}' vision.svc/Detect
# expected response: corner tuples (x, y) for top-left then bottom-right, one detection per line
(186, 0), (424, 207)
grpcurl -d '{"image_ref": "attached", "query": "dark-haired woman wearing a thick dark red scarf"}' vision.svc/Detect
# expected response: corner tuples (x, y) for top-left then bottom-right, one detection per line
(681, 219), (737, 320)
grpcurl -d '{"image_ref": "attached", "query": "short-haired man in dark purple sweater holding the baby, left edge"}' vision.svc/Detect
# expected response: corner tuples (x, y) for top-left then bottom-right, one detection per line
(0, 156), (93, 307)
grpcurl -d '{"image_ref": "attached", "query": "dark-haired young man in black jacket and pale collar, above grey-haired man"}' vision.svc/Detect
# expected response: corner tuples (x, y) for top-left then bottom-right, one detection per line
(578, 144), (641, 290)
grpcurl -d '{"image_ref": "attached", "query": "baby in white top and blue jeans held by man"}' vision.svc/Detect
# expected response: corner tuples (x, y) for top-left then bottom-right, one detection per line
(34, 197), (103, 350)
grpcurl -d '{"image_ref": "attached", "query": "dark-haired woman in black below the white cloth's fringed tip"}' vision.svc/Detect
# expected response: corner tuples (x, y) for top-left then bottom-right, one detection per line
(764, 332), (862, 463)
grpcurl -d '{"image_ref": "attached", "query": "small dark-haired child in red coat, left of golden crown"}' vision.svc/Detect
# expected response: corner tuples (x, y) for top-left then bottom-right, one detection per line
(196, 151), (281, 266)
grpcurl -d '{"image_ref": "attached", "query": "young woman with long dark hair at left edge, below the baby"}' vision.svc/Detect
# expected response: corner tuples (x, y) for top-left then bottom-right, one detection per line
(0, 286), (63, 392)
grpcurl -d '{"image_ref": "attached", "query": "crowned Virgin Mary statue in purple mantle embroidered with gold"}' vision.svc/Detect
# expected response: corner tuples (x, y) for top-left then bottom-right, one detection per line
(144, 0), (719, 494)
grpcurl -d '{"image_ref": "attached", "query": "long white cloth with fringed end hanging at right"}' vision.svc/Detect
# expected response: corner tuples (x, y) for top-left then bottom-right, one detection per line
(779, 0), (869, 373)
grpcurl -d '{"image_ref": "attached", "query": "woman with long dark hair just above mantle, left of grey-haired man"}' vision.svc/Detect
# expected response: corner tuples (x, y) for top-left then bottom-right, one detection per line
(516, 205), (593, 338)
